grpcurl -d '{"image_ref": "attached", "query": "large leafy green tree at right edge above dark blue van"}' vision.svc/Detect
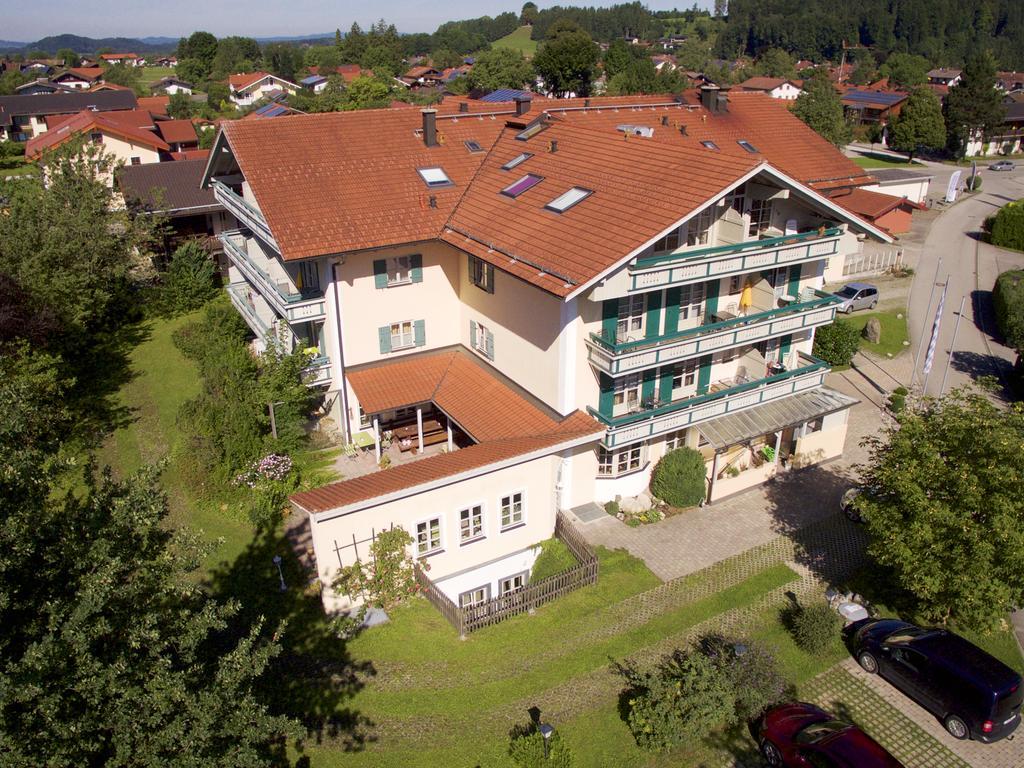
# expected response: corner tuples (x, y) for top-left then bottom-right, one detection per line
(856, 391), (1024, 629)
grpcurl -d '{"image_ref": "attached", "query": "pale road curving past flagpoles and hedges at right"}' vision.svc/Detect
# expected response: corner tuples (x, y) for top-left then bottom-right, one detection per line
(907, 164), (1024, 395)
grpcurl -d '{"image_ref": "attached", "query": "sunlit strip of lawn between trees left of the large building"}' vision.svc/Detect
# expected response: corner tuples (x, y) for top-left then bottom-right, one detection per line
(100, 312), (252, 564)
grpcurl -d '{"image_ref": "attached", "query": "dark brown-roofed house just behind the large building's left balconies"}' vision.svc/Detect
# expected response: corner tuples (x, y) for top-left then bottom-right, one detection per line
(117, 153), (239, 266)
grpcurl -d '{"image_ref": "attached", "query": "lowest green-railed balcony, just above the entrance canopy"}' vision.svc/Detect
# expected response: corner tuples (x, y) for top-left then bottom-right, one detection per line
(587, 353), (829, 449)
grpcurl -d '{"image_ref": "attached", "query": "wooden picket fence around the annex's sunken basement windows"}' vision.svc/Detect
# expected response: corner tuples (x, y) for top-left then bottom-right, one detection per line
(416, 512), (598, 637)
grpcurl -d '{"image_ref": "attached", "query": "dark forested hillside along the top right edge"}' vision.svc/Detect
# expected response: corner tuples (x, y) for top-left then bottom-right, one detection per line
(716, 0), (1024, 70)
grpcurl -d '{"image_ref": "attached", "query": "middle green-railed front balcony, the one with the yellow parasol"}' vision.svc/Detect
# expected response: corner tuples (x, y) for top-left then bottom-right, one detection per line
(588, 290), (840, 376)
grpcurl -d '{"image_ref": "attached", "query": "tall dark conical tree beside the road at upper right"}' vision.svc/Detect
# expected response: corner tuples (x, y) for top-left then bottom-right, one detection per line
(946, 51), (1007, 158)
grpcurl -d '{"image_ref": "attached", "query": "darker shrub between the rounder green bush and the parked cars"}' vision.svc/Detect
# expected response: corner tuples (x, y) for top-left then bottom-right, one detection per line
(700, 635), (792, 722)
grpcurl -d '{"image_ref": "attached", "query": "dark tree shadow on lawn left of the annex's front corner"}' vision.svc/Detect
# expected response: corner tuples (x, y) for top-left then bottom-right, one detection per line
(208, 528), (376, 752)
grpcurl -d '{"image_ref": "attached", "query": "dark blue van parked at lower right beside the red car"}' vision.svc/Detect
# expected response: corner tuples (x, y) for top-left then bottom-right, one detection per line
(847, 618), (1024, 743)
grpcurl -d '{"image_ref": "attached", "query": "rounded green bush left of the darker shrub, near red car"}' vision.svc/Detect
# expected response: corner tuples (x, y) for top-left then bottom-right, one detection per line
(618, 650), (735, 751)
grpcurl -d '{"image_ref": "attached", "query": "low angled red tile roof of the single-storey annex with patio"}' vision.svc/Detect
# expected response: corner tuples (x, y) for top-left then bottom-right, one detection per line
(292, 347), (604, 512)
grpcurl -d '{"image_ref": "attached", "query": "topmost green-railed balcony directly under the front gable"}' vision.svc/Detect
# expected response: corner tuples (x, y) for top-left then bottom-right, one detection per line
(629, 226), (846, 291)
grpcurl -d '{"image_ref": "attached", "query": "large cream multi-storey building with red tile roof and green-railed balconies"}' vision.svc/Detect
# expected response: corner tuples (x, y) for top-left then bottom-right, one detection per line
(199, 88), (891, 610)
